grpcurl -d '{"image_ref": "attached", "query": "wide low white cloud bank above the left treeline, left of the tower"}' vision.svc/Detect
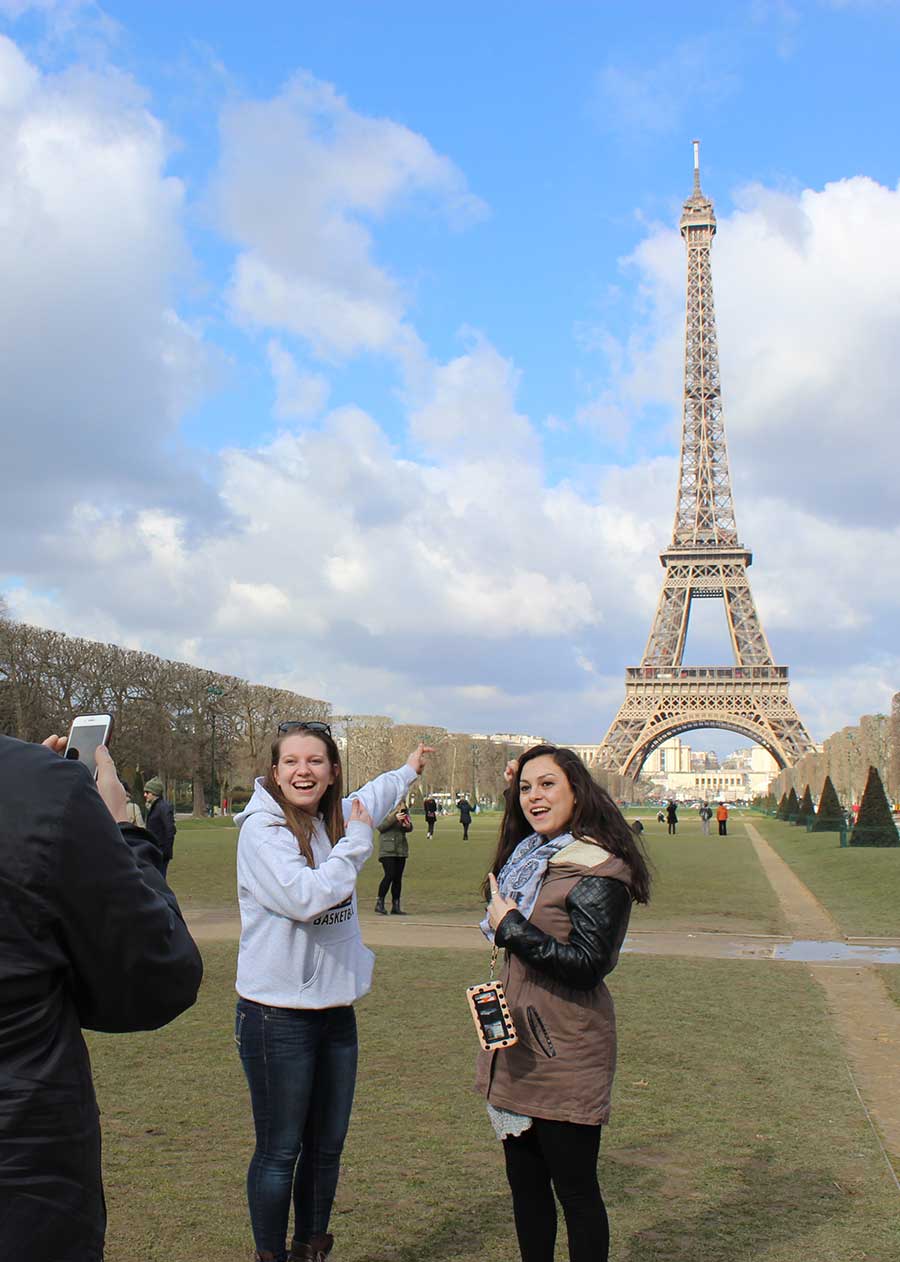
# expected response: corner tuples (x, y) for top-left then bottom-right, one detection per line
(3, 339), (654, 727)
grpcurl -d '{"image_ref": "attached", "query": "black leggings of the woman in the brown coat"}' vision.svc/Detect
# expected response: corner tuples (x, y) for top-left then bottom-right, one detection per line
(504, 1118), (610, 1262)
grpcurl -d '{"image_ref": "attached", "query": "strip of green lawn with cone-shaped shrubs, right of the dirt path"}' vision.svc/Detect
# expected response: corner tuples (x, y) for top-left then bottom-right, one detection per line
(752, 815), (900, 938)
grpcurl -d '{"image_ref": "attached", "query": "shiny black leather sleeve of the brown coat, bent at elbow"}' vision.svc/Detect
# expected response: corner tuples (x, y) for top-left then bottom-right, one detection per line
(495, 876), (631, 991)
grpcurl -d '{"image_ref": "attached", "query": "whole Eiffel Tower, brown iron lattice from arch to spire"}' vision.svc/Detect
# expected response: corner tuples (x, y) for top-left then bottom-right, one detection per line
(595, 141), (814, 779)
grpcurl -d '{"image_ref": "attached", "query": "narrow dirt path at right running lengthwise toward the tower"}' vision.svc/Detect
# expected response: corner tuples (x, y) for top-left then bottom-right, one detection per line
(743, 822), (900, 1159)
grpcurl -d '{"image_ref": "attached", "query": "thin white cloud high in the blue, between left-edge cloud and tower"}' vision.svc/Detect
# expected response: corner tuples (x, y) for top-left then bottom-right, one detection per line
(217, 73), (483, 357)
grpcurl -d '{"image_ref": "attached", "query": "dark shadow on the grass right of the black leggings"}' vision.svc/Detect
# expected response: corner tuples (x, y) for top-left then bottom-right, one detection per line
(613, 1148), (846, 1262)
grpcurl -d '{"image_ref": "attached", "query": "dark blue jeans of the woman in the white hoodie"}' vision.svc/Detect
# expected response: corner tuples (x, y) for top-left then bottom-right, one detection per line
(235, 1000), (357, 1262)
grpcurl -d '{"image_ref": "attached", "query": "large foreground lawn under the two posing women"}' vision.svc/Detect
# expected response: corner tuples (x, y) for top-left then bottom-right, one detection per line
(90, 943), (900, 1262)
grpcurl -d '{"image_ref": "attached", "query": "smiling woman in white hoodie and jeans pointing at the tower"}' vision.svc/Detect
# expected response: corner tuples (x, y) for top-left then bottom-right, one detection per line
(235, 722), (430, 1262)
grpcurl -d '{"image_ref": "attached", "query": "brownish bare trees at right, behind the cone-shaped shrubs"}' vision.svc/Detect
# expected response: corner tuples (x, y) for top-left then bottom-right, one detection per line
(769, 693), (900, 805)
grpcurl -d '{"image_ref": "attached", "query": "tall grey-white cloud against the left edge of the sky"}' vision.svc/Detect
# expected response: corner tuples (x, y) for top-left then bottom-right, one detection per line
(0, 37), (217, 552)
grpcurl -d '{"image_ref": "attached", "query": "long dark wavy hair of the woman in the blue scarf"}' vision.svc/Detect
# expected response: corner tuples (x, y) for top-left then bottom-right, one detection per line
(483, 745), (650, 902)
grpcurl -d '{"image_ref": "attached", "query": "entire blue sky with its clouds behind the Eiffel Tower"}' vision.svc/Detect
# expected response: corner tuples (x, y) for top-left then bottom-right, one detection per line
(0, 0), (900, 747)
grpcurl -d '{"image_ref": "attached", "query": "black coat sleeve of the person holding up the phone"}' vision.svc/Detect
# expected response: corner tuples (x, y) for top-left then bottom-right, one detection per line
(48, 760), (203, 1032)
